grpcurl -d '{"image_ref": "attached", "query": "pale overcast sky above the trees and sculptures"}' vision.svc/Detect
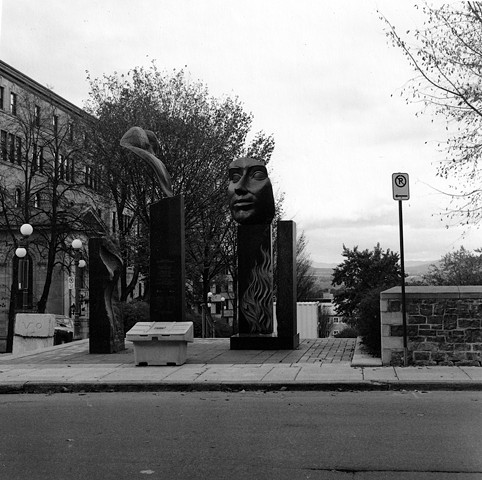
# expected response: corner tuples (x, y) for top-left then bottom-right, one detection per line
(0, 0), (476, 263)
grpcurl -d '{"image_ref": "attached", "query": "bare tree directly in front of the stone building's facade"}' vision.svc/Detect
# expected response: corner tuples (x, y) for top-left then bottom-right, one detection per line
(0, 91), (103, 348)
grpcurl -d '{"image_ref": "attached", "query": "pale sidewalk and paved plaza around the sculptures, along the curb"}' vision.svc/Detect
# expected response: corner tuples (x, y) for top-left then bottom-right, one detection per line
(0, 339), (482, 393)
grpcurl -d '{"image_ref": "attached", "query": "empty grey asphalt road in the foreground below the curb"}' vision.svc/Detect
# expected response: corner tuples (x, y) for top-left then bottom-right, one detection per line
(0, 391), (482, 480)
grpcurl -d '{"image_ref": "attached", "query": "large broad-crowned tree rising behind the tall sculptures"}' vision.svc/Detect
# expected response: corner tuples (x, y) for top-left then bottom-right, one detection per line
(87, 62), (274, 308)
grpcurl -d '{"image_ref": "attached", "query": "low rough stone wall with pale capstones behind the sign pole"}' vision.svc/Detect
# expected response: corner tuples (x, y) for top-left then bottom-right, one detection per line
(380, 286), (482, 366)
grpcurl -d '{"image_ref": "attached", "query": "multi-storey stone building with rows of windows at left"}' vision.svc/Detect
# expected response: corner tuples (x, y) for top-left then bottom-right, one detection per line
(0, 61), (112, 352)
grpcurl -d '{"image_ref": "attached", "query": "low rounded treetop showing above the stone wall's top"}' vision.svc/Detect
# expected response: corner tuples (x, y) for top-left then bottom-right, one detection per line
(423, 247), (482, 285)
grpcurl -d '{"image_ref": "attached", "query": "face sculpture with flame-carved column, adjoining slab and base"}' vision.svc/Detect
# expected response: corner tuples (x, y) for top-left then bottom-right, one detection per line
(228, 157), (299, 350)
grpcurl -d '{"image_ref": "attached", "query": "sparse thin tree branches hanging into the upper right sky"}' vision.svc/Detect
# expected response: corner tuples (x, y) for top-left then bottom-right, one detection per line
(381, 2), (482, 224)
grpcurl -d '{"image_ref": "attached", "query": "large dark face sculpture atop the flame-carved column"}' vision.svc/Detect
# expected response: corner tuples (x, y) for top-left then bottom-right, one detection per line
(228, 157), (274, 225)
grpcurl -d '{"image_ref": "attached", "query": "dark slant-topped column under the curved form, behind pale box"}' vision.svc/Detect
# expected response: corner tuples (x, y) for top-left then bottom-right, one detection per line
(149, 196), (186, 322)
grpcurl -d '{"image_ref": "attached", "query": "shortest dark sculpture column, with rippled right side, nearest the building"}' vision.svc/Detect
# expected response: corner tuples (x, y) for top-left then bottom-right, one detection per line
(89, 238), (125, 353)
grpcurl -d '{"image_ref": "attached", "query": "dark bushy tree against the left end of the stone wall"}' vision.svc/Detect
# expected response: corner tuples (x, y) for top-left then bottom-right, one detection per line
(332, 244), (401, 354)
